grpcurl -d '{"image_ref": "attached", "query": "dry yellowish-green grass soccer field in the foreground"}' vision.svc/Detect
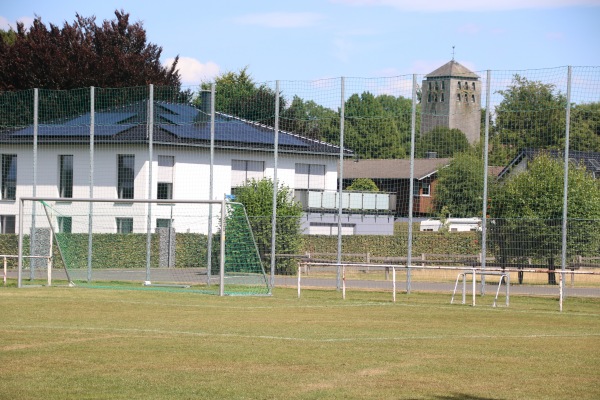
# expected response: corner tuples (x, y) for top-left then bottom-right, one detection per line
(0, 287), (600, 399)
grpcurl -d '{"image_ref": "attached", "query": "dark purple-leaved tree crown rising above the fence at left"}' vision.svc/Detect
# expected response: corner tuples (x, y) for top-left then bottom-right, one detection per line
(0, 10), (181, 90)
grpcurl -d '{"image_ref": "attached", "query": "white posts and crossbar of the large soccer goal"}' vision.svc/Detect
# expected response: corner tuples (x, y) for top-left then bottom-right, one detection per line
(17, 197), (227, 296)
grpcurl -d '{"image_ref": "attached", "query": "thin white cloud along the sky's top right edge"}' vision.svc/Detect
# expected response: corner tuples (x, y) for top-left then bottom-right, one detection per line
(330, 0), (600, 12)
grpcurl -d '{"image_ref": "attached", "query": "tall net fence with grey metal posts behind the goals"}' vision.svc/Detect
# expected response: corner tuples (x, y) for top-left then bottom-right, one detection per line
(0, 66), (600, 304)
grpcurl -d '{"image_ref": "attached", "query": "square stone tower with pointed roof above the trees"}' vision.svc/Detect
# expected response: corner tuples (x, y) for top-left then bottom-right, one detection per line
(421, 60), (481, 144)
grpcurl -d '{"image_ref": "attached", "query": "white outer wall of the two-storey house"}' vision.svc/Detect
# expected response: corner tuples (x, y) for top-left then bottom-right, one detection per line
(0, 144), (338, 232)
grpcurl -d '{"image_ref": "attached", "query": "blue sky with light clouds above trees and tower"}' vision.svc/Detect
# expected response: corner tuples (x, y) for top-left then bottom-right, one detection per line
(0, 0), (600, 85)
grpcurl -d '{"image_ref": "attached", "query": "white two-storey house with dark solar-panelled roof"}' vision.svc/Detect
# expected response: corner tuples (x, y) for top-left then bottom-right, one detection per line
(0, 101), (393, 233)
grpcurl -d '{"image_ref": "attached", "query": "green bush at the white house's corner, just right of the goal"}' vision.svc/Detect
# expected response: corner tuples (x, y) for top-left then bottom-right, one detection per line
(235, 178), (302, 275)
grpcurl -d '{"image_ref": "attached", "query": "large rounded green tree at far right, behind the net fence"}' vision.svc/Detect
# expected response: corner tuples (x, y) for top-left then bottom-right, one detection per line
(489, 154), (600, 283)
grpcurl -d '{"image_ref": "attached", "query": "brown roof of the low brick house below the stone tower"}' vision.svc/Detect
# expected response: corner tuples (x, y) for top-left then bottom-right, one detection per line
(344, 158), (451, 180)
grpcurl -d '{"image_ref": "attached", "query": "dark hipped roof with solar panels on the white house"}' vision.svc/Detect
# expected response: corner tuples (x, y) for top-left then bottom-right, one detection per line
(0, 101), (352, 155)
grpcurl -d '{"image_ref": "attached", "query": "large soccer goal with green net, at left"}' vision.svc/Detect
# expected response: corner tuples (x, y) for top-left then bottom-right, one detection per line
(18, 197), (271, 295)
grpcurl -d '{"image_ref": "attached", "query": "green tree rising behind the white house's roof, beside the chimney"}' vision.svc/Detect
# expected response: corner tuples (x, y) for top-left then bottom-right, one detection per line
(198, 66), (286, 126)
